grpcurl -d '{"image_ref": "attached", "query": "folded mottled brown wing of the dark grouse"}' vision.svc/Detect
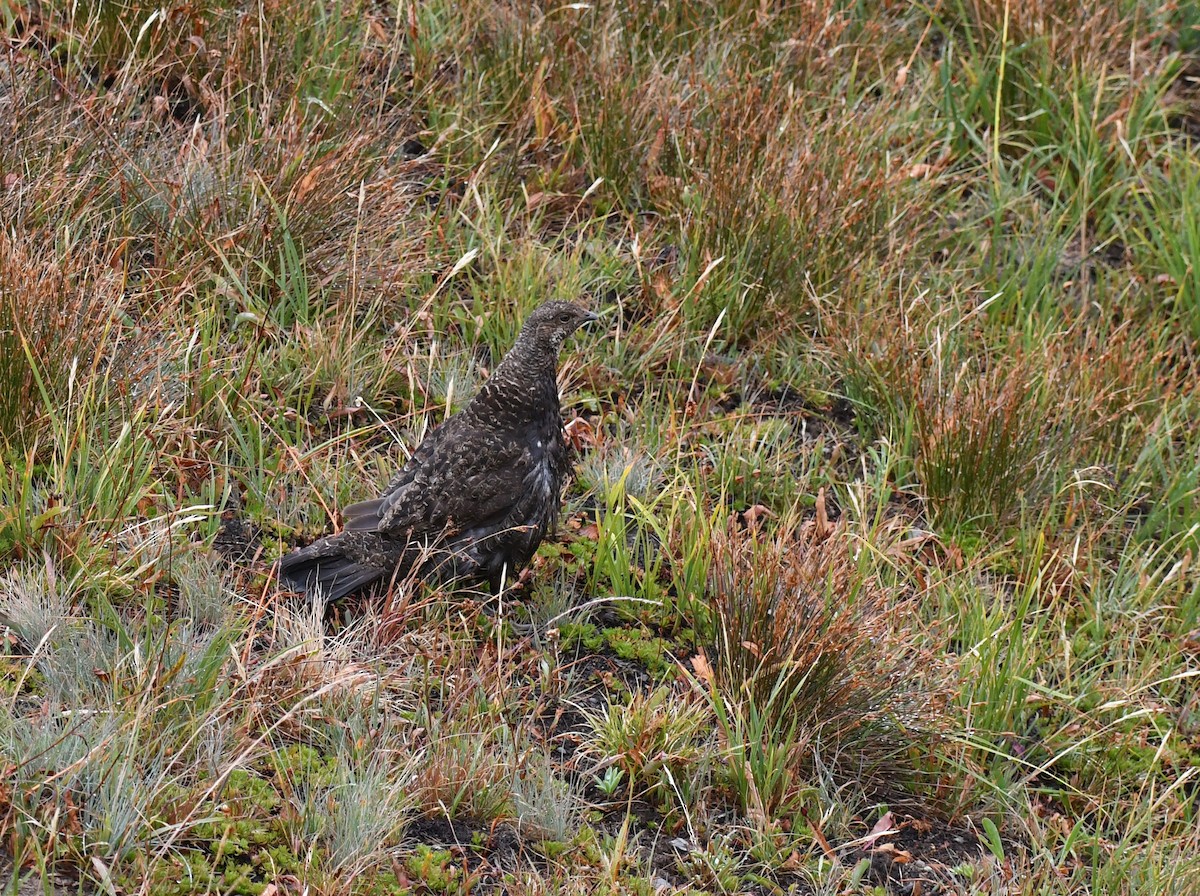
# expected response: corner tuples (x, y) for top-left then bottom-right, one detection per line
(344, 417), (542, 537)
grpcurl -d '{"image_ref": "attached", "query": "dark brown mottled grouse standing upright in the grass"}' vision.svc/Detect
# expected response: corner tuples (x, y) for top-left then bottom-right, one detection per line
(278, 301), (598, 602)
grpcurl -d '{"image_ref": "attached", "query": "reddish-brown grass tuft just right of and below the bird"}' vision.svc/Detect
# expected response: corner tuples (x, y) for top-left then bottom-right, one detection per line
(704, 515), (953, 834)
